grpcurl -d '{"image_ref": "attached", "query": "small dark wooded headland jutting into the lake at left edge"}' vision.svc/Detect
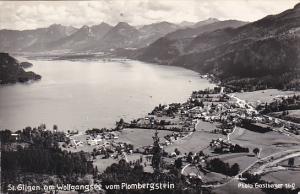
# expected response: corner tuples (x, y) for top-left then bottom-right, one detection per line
(0, 53), (41, 84)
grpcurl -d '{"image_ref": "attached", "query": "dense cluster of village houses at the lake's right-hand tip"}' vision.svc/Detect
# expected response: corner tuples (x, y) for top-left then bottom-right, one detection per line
(186, 93), (300, 134)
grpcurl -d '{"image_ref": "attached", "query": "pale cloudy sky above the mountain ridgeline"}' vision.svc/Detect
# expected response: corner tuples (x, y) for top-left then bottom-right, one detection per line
(0, 0), (300, 30)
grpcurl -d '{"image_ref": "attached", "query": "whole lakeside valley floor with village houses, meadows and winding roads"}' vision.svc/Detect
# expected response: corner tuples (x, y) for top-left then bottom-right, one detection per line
(2, 87), (300, 190)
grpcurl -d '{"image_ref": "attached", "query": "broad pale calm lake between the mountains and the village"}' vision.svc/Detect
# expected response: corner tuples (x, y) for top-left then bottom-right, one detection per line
(0, 60), (214, 131)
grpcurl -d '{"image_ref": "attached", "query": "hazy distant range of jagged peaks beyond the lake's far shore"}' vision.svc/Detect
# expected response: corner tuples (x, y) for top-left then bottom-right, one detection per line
(0, 18), (245, 52)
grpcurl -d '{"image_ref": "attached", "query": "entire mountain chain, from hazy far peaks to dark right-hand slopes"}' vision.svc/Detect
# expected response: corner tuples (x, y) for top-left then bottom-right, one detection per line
(0, 4), (300, 91)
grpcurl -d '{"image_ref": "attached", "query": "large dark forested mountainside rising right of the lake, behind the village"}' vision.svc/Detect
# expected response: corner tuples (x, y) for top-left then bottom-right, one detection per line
(135, 4), (300, 90)
